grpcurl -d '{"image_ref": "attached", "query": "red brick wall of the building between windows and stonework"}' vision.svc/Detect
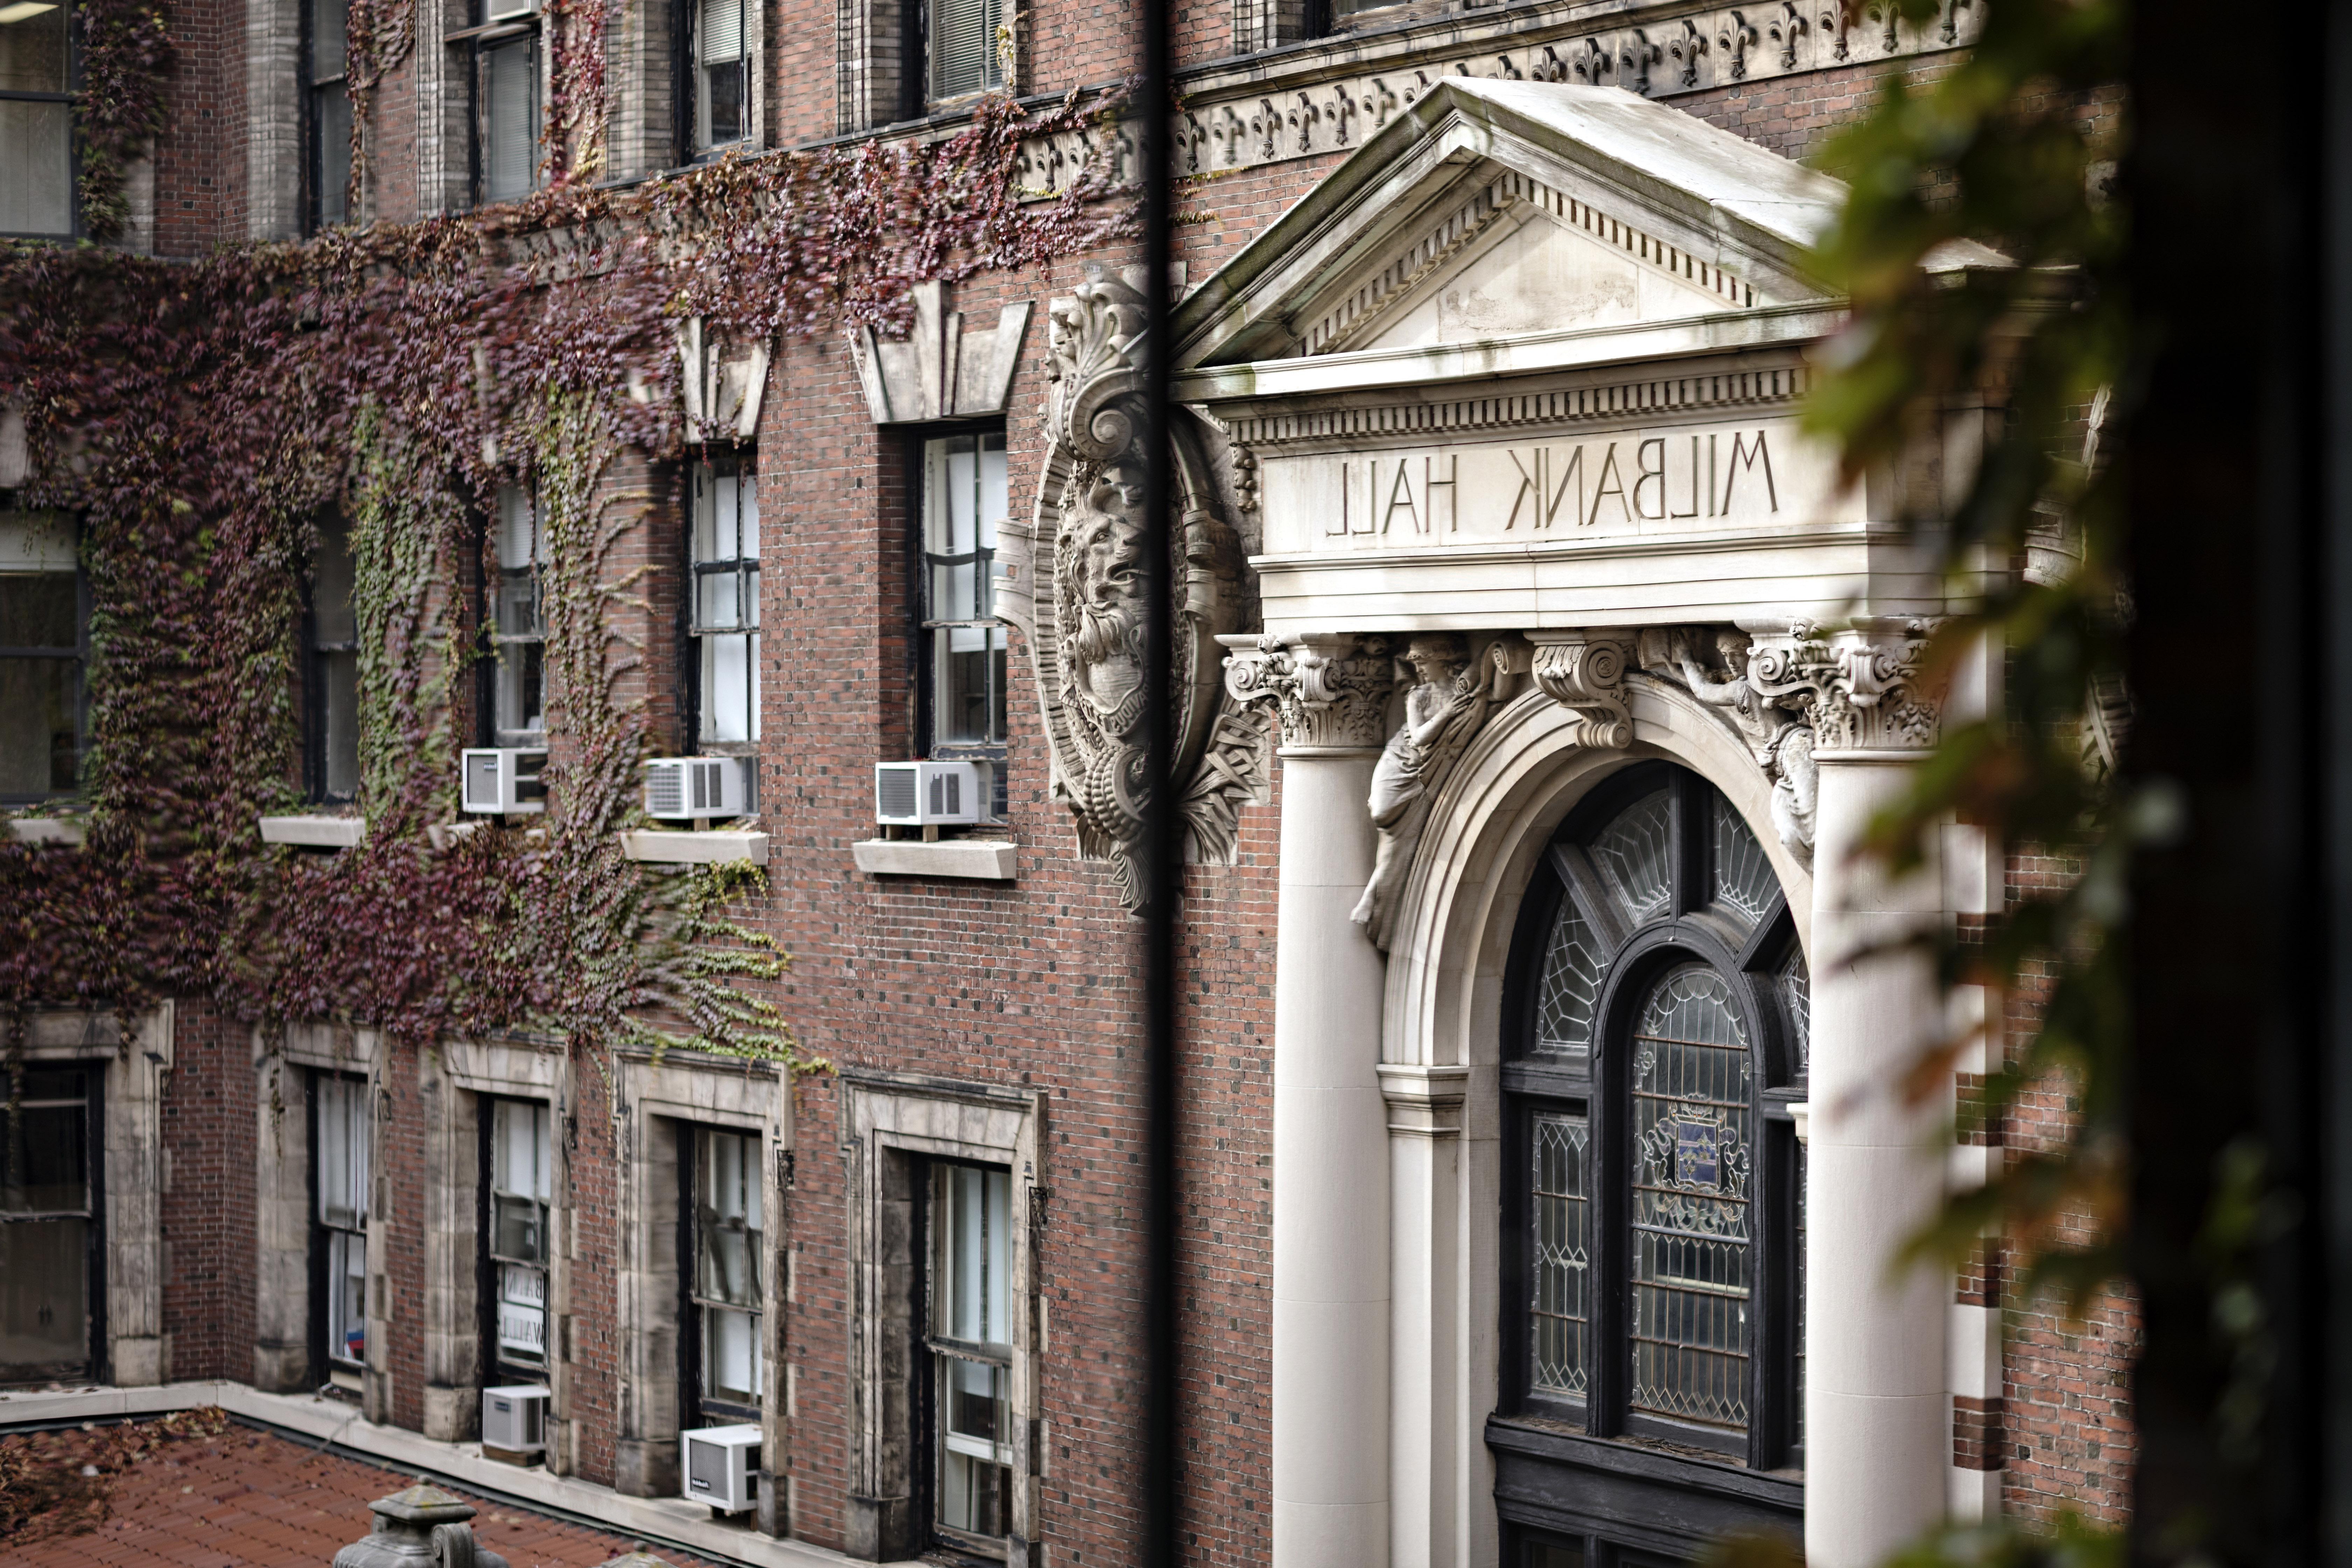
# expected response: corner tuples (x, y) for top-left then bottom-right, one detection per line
(41, 0), (2133, 1568)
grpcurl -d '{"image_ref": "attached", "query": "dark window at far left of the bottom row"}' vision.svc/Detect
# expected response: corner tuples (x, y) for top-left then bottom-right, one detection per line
(0, 1067), (106, 1382)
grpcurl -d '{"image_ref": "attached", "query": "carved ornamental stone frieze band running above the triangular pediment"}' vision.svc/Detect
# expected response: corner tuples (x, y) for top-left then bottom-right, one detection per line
(1016, 0), (1983, 200)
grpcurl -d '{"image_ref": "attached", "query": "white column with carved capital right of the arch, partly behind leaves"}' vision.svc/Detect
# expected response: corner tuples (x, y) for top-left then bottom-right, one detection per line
(1750, 625), (1952, 1568)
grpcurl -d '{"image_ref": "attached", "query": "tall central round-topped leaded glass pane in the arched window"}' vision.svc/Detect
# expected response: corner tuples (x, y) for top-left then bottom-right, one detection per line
(1630, 964), (1752, 1429)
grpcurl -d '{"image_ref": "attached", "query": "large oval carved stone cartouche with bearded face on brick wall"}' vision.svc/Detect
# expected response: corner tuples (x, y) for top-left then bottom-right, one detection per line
(997, 268), (1268, 910)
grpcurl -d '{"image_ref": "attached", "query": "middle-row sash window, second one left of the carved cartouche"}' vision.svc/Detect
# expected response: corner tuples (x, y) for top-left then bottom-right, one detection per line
(687, 456), (760, 743)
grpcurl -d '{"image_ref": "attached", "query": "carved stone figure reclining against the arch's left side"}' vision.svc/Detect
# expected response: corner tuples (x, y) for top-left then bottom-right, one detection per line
(1352, 632), (1510, 952)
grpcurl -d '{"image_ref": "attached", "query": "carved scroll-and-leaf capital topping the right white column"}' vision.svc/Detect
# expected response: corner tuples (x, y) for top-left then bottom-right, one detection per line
(1748, 618), (1943, 762)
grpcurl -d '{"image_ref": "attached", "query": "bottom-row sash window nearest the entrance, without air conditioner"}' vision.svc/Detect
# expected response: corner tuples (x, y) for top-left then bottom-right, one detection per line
(924, 1161), (1014, 1547)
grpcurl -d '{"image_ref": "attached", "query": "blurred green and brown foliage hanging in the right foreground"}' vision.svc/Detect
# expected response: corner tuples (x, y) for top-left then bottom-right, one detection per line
(1787, 0), (2145, 1568)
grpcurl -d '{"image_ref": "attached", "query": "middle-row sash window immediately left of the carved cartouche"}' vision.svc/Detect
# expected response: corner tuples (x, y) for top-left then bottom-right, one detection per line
(922, 433), (1009, 811)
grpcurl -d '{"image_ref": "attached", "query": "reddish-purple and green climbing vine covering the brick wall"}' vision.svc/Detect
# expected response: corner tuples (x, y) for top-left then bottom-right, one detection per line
(0, 92), (1134, 1060)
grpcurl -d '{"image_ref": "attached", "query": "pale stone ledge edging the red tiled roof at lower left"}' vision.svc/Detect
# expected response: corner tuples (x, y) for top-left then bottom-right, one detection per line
(0, 1382), (920, 1568)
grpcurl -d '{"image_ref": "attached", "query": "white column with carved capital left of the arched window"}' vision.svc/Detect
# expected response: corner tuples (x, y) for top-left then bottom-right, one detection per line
(1225, 637), (1390, 1568)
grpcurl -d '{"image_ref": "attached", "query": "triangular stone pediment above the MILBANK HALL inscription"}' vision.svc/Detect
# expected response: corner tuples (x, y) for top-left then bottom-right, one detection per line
(1171, 78), (1999, 369)
